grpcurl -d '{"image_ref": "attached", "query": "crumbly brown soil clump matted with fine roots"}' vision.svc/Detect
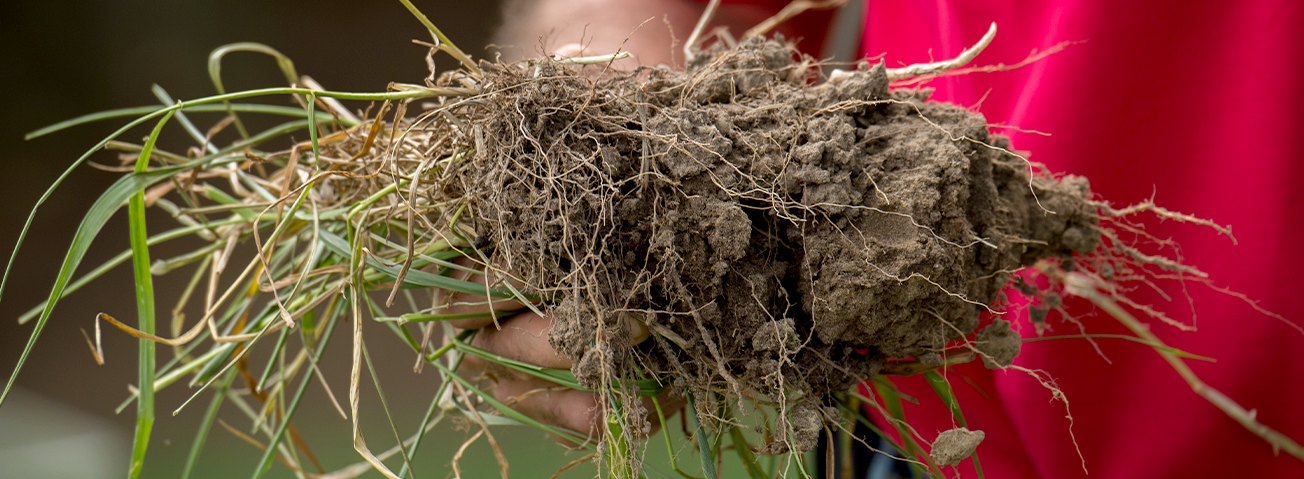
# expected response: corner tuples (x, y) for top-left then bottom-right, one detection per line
(443, 39), (1101, 449)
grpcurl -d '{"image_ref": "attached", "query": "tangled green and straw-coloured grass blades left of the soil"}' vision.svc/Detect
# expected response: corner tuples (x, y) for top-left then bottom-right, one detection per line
(0, 28), (824, 478)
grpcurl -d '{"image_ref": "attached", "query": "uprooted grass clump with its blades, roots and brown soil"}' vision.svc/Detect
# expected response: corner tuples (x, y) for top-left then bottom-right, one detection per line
(0, 1), (1304, 478)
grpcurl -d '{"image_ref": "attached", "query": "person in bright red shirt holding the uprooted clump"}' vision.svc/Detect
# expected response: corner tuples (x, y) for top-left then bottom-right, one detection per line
(449, 0), (1304, 478)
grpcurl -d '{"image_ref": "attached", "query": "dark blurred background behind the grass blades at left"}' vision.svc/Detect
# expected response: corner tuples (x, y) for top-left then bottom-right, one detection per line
(0, 0), (620, 478)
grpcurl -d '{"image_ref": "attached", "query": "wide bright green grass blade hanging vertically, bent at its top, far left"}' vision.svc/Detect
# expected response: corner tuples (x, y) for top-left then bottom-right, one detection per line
(128, 111), (172, 479)
